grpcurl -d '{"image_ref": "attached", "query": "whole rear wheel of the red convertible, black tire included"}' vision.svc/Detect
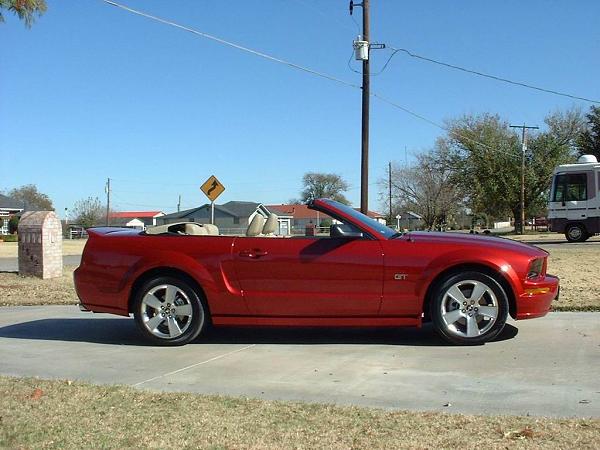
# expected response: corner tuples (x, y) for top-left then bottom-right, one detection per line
(133, 277), (210, 346)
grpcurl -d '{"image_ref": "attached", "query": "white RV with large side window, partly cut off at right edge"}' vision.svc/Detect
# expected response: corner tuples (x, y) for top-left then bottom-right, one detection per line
(548, 155), (600, 242)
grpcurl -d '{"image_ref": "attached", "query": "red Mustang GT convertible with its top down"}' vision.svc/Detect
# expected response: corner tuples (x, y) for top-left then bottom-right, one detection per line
(75, 199), (559, 345)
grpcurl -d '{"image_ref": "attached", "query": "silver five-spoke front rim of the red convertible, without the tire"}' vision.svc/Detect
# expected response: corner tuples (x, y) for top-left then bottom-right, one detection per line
(440, 280), (499, 338)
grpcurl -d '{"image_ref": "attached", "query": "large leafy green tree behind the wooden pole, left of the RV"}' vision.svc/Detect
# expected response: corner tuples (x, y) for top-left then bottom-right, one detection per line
(444, 110), (582, 223)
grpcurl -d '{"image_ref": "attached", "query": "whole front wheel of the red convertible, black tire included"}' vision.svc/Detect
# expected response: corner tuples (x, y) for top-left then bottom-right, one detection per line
(430, 271), (508, 345)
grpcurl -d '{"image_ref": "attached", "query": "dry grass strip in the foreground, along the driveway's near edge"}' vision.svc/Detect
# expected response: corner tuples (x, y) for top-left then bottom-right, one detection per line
(0, 377), (600, 449)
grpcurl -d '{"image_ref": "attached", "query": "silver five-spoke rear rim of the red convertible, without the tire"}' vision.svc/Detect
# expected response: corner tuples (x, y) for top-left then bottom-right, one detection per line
(140, 284), (197, 339)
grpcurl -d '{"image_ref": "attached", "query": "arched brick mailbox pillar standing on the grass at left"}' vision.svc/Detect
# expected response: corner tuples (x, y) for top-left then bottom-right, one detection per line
(18, 211), (63, 279)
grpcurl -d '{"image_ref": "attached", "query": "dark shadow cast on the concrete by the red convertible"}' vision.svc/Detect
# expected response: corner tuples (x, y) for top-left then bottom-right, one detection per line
(0, 318), (519, 347)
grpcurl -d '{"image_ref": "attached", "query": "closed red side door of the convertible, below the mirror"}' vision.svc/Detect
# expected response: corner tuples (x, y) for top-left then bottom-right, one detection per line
(233, 232), (383, 317)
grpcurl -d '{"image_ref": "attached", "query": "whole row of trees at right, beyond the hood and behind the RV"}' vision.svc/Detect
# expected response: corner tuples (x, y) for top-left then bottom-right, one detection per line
(380, 106), (600, 229)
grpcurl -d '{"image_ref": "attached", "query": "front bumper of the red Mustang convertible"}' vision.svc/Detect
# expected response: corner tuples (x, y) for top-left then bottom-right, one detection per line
(515, 275), (560, 320)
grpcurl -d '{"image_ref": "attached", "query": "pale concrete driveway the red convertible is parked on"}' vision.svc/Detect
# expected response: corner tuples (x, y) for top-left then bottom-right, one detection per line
(0, 306), (600, 417)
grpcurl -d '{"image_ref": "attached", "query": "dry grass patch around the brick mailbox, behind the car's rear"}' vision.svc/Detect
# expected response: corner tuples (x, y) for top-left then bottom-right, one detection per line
(0, 267), (79, 308)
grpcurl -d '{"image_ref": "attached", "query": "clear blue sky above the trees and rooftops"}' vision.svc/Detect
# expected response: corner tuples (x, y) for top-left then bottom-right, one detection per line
(0, 0), (600, 215)
